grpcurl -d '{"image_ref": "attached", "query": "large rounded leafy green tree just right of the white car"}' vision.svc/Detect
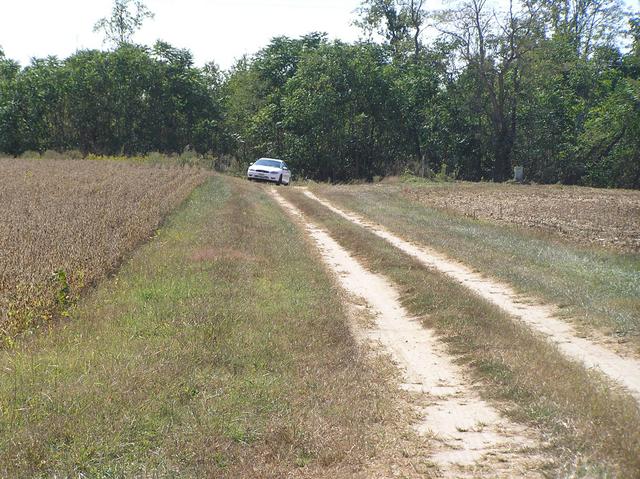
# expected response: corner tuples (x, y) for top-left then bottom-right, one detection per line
(284, 42), (403, 180)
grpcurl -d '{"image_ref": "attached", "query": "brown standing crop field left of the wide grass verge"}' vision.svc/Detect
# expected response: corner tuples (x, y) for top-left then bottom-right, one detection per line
(0, 159), (209, 344)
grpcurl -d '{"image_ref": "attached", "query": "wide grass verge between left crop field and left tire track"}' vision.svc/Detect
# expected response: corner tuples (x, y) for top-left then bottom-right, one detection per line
(0, 177), (397, 477)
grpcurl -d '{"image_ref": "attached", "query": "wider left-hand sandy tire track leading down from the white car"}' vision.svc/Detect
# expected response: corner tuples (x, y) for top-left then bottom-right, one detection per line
(273, 191), (543, 478)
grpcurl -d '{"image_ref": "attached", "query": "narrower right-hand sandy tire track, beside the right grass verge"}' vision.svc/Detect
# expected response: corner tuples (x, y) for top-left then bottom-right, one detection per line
(304, 190), (640, 402)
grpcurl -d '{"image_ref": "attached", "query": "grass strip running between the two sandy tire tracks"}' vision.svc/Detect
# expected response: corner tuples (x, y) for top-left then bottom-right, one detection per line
(285, 191), (640, 477)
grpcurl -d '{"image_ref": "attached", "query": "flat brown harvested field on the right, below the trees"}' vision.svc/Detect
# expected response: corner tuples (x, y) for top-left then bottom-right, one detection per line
(402, 182), (640, 251)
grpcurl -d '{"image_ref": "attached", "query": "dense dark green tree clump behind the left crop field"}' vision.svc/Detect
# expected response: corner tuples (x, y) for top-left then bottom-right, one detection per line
(0, 42), (223, 155)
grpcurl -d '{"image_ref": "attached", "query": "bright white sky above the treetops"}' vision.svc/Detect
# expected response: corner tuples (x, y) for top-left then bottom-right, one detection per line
(0, 0), (640, 69)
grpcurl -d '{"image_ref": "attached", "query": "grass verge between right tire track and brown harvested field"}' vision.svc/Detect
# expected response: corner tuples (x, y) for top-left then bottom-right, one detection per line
(314, 186), (640, 353)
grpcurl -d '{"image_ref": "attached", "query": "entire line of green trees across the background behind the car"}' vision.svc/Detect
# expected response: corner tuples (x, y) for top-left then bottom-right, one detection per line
(0, 0), (640, 188)
